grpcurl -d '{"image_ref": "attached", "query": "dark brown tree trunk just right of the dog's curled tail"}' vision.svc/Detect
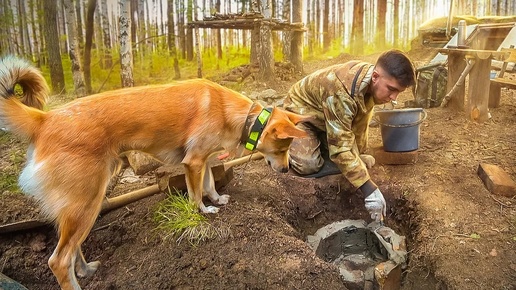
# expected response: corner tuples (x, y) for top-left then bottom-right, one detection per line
(43, 0), (66, 94)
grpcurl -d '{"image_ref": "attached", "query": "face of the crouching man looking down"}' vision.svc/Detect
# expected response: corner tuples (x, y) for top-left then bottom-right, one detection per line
(371, 67), (406, 105)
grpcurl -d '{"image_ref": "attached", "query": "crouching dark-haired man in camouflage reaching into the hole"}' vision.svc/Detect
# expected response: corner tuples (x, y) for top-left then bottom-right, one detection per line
(285, 49), (415, 221)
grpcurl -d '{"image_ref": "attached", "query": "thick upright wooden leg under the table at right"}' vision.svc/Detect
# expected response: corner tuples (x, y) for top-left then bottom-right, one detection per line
(466, 57), (491, 123)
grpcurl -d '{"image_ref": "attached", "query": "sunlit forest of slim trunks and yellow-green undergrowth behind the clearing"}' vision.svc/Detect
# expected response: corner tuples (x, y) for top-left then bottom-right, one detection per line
(0, 0), (516, 97)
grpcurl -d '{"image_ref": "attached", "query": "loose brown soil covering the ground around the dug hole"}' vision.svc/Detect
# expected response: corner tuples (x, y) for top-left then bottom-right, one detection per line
(0, 49), (516, 290)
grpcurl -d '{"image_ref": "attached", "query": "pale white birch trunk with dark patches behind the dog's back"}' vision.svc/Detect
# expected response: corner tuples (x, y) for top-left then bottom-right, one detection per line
(118, 0), (134, 87)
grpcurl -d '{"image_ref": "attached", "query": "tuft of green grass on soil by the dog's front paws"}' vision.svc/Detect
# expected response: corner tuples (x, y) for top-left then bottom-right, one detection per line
(153, 190), (223, 246)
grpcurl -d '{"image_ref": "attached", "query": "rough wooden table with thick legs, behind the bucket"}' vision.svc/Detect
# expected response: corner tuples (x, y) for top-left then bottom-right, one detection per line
(439, 47), (509, 123)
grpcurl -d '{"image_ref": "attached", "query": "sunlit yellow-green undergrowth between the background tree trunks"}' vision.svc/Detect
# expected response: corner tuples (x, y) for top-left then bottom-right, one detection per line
(42, 39), (374, 97)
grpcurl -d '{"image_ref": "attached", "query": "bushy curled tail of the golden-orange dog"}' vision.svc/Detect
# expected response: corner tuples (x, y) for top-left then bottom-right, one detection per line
(0, 56), (49, 139)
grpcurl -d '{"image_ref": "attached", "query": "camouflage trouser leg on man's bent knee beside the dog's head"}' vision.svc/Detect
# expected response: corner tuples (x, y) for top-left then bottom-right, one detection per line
(289, 123), (328, 175)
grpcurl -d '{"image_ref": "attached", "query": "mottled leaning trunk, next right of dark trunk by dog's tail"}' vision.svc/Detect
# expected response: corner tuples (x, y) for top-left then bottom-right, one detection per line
(63, 0), (86, 97)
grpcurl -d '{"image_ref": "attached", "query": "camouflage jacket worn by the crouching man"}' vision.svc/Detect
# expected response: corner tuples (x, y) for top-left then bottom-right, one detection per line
(285, 61), (374, 188)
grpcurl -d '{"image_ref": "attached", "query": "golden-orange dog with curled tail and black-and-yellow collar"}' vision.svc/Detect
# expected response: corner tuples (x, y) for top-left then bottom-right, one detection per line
(0, 56), (308, 289)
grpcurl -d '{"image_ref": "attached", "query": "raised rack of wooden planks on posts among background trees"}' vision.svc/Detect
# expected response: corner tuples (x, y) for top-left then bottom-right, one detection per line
(188, 12), (306, 80)
